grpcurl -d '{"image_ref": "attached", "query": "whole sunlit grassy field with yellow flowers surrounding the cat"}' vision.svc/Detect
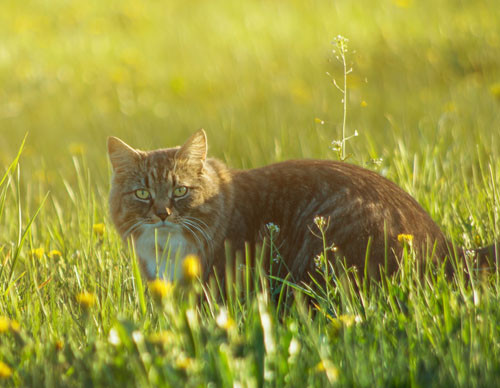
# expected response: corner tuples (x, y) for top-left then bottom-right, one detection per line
(0, 0), (500, 387)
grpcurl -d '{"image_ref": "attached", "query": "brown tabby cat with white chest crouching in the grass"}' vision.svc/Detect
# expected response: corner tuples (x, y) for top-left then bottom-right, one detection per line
(108, 130), (494, 282)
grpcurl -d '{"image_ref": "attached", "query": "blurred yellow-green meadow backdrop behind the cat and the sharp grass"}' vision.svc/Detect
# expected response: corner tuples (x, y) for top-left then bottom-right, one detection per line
(0, 0), (500, 212)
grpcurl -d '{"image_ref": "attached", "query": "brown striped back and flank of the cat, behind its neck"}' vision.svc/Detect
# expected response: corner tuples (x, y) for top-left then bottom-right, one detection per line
(229, 159), (446, 273)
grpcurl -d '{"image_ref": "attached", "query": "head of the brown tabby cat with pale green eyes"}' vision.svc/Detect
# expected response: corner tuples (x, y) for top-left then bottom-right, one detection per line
(108, 129), (214, 239)
